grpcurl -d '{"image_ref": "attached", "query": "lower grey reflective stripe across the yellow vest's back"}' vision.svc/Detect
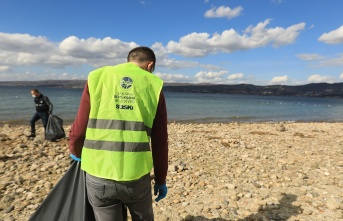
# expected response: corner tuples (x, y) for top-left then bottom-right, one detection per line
(84, 139), (150, 152)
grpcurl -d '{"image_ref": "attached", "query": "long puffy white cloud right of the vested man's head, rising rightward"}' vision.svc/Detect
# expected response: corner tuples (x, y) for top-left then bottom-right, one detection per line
(166, 19), (305, 57)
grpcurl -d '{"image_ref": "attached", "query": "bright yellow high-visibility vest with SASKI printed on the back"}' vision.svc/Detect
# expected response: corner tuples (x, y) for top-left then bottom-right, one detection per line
(81, 63), (163, 181)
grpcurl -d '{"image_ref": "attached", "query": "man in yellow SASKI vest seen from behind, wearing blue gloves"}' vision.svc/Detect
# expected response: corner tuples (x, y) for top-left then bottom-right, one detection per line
(69, 47), (168, 221)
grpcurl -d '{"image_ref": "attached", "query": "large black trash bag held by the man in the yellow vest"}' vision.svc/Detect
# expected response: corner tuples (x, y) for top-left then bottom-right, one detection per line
(29, 161), (95, 221)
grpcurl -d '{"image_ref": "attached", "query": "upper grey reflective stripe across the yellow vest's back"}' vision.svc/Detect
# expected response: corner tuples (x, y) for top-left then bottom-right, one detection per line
(87, 119), (151, 137)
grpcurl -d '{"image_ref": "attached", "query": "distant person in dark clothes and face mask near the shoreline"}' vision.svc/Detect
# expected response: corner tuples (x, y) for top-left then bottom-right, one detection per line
(28, 88), (53, 137)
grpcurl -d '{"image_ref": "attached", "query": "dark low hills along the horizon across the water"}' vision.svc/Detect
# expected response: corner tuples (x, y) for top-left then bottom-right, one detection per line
(0, 80), (343, 98)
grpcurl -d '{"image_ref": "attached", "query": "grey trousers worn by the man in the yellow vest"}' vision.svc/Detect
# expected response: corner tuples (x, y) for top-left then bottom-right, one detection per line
(86, 173), (154, 221)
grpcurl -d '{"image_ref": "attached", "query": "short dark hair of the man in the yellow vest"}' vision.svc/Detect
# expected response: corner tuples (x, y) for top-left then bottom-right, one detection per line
(127, 46), (156, 71)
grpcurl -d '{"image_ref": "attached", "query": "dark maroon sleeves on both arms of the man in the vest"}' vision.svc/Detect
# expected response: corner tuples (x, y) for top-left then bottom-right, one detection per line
(69, 84), (168, 184)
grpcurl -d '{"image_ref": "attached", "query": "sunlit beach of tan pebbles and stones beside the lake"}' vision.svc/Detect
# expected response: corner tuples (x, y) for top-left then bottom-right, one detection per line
(0, 122), (343, 221)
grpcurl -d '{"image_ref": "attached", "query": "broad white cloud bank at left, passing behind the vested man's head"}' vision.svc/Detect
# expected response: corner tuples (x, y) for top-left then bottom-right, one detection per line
(0, 33), (219, 80)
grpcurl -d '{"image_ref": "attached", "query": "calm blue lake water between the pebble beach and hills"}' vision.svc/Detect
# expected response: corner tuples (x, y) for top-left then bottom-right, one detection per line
(0, 87), (343, 124)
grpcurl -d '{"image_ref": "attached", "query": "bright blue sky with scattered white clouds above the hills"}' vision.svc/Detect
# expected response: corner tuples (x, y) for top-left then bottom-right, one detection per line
(0, 0), (343, 85)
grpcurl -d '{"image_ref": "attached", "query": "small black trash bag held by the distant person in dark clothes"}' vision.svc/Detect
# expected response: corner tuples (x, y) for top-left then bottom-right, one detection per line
(45, 114), (66, 141)
